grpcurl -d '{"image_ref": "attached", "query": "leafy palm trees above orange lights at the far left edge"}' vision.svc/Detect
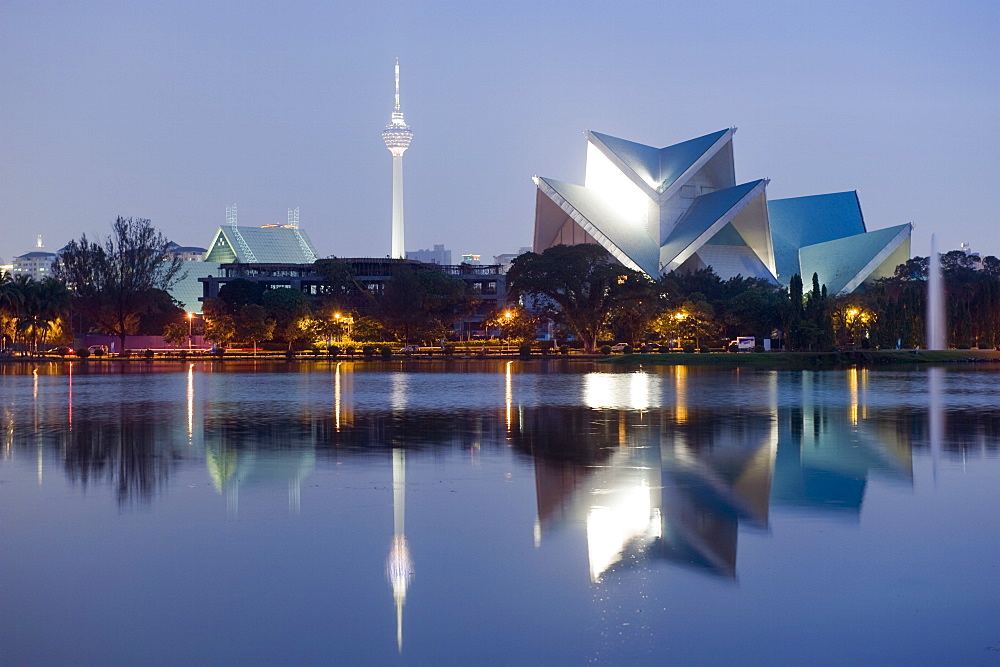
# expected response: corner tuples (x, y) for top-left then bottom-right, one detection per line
(0, 272), (70, 353)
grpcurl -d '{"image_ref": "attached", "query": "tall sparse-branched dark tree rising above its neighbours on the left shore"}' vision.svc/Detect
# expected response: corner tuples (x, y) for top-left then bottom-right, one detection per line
(53, 216), (184, 352)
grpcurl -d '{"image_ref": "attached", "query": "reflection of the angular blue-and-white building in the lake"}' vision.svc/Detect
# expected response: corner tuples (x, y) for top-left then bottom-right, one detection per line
(519, 367), (912, 582)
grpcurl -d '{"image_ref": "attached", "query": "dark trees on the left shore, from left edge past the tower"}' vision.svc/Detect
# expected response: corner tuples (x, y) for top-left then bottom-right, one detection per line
(0, 217), (481, 352)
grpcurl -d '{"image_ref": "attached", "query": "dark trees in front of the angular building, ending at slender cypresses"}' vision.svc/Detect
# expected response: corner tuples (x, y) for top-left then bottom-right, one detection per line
(507, 244), (830, 350)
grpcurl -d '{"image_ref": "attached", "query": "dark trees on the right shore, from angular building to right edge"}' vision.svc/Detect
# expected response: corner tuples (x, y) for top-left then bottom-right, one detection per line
(507, 245), (1000, 350)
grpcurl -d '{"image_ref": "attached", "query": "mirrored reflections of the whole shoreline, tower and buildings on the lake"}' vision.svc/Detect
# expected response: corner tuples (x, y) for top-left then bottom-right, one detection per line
(0, 361), (1000, 576)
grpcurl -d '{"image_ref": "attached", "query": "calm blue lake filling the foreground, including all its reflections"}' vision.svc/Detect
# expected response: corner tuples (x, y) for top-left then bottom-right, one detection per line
(0, 360), (1000, 665)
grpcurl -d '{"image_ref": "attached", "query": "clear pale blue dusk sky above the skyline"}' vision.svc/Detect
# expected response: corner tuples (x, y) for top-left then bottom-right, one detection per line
(0, 0), (1000, 261)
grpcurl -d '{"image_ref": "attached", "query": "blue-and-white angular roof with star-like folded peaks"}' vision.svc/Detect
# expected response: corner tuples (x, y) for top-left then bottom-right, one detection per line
(534, 128), (911, 294)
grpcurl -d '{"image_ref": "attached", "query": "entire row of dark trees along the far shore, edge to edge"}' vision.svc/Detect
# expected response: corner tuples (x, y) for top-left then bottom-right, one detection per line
(0, 217), (1000, 352)
